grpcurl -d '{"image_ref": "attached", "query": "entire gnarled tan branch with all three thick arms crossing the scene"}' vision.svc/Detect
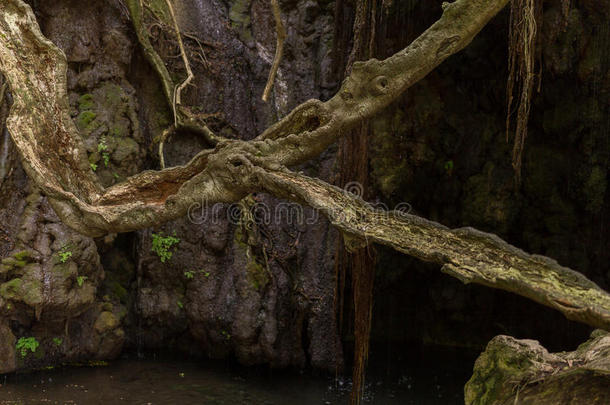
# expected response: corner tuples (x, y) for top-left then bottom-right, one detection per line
(0, 0), (610, 330)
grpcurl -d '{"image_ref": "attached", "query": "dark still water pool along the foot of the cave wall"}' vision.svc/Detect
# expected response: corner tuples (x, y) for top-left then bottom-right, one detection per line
(0, 348), (468, 405)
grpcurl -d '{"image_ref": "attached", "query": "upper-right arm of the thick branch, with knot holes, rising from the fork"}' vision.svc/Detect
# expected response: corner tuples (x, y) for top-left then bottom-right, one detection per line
(258, 0), (508, 166)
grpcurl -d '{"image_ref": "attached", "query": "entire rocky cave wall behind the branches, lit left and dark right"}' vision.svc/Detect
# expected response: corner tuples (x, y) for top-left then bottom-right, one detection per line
(0, 0), (610, 372)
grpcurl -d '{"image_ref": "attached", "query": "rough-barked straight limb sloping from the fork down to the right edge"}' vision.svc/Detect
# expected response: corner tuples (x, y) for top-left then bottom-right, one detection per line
(259, 171), (610, 330)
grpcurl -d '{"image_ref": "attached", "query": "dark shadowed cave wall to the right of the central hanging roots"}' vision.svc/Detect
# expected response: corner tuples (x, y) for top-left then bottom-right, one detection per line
(370, 1), (610, 351)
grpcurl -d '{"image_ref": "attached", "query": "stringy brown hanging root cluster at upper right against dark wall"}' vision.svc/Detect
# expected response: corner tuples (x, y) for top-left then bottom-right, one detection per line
(506, 0), (541, 185)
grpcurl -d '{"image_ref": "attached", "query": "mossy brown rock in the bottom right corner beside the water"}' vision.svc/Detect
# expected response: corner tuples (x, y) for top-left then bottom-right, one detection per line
(464, 330), (610, 405)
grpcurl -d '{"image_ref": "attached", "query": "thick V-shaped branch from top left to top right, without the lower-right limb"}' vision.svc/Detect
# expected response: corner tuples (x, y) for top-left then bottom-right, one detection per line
(0, 0), (507, 235)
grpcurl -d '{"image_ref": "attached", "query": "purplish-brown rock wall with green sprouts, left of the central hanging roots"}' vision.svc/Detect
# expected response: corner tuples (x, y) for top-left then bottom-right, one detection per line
(0, 0), (342, 372)
